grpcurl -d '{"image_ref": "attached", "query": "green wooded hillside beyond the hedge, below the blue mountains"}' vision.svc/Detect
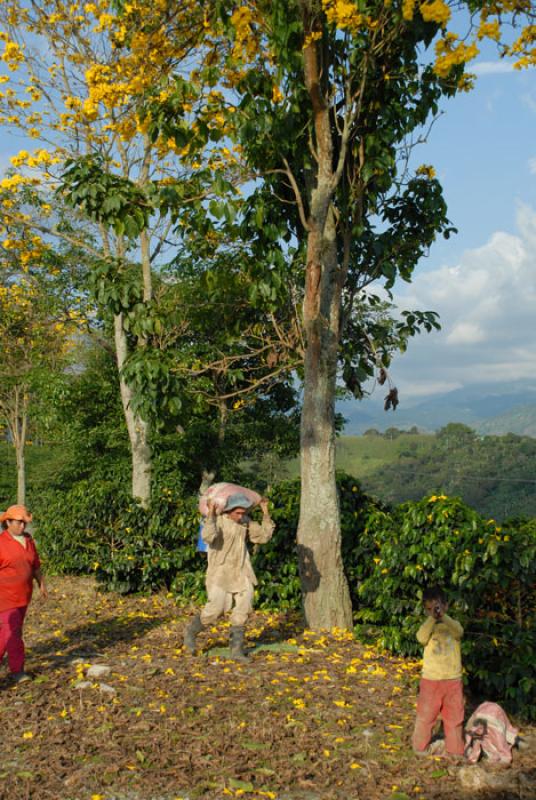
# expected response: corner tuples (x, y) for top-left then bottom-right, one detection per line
(280, 424), (536, 520)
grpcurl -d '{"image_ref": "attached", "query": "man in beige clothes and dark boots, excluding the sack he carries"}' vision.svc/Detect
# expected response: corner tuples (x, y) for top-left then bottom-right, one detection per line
(184, 492), (275, 661)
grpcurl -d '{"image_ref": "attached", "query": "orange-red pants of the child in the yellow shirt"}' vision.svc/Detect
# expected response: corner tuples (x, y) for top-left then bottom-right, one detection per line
(412, 678), (464, 756)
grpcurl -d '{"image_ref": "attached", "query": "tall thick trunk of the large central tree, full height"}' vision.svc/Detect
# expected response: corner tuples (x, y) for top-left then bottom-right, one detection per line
(298, 31), (353, 630)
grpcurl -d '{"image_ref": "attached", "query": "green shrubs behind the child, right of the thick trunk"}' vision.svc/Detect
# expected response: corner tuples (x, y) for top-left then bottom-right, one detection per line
(356, 495), (536, 717)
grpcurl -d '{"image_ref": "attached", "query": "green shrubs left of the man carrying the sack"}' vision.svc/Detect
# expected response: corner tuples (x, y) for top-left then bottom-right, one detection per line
(30, 481), (205, 597)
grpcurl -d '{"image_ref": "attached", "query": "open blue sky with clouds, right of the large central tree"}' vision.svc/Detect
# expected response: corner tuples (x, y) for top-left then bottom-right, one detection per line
(363, 51), (536, 410)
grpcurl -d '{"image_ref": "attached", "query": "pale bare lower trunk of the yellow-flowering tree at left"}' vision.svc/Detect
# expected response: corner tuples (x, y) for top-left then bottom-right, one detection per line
(114, 314), (152, 507)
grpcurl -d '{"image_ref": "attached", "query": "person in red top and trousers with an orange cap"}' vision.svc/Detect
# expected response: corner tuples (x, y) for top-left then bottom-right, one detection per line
(0, 506), (48, 683)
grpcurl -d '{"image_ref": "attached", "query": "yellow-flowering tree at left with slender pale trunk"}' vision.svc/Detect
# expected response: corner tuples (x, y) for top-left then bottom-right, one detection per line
(0, 0), (241, 504)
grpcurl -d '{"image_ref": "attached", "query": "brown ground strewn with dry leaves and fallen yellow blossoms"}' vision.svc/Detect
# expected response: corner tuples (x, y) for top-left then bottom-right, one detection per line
(0, 578), (536, 800)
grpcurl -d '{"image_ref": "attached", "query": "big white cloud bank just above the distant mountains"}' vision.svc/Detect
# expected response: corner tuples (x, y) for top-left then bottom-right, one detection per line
(392, 204), (536, 398)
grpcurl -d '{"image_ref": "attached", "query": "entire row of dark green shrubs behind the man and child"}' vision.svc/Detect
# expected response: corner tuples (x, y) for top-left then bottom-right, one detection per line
(34, 475), (536, 718)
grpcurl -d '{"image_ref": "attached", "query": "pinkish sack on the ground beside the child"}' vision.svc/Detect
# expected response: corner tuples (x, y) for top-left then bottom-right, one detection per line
(465, 702), (518, 764)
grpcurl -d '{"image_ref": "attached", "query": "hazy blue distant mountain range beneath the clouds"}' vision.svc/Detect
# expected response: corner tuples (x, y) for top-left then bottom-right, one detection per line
(337, 381), (536, 437)
